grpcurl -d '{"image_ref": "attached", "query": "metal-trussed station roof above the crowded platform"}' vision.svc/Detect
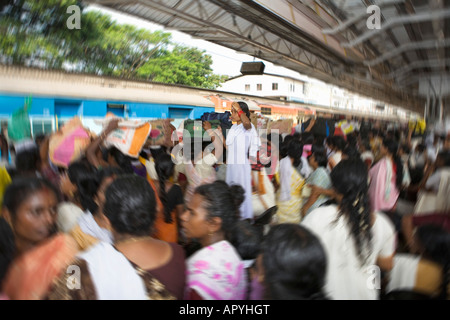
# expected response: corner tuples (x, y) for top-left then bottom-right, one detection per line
(84, 0), (450, 114)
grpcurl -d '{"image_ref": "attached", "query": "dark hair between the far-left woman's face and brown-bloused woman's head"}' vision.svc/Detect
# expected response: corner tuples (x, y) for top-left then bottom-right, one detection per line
(67, 158), (99, 214)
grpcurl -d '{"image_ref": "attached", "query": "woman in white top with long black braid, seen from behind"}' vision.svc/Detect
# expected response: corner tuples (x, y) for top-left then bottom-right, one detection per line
(301, 159), (397, 300)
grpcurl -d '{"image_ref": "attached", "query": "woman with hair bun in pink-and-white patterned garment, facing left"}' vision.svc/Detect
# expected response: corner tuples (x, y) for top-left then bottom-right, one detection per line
(181, 181), (247, 300)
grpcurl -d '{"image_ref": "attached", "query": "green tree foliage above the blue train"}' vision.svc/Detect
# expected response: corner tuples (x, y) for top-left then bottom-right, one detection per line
(0, 0), (227, 89)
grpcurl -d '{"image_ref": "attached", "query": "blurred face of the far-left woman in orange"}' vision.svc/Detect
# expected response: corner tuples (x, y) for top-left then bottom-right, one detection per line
(12, 188), (58, 243)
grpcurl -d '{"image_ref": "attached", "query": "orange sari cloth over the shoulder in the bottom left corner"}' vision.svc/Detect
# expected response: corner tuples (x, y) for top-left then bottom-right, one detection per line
(3, 233), (78, 300)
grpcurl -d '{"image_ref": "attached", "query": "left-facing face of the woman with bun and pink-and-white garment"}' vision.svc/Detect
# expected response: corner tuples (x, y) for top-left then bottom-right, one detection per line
(181, 194), (209, 239)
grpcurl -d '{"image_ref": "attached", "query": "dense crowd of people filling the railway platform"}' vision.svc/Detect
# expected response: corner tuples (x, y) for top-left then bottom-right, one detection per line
(0, 102), (450, 300)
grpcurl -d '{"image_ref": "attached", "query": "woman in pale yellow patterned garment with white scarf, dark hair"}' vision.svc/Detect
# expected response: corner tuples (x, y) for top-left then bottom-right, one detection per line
(276, 139), (305, 223)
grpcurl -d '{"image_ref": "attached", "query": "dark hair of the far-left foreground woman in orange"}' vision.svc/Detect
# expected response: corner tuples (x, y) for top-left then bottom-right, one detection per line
(3, 177), (60, 218)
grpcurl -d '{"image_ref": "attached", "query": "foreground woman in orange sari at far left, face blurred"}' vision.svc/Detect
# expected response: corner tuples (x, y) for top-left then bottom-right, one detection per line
(3, 178), (78, 300)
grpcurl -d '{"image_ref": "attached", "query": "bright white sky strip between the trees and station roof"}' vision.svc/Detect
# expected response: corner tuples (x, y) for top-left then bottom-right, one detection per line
(86, 5), (305, 78)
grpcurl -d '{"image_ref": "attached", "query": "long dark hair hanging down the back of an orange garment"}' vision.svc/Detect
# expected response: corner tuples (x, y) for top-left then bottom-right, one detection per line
(155, 153), (175, 223)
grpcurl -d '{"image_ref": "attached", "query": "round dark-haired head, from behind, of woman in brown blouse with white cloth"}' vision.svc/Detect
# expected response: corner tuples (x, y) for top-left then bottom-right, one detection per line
(103, 174), (156, 236)
